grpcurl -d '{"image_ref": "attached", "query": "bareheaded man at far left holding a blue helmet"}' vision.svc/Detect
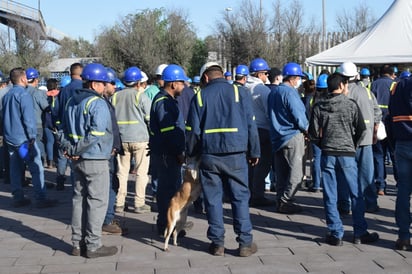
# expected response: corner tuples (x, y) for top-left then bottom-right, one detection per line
(2, 68), (57, 208)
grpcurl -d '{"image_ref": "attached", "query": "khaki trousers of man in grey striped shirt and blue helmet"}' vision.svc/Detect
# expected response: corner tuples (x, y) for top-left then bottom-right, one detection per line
(116, 142), (149, 208)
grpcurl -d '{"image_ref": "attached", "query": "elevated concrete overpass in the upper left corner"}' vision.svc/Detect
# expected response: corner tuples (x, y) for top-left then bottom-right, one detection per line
(0, 0), (67, 45)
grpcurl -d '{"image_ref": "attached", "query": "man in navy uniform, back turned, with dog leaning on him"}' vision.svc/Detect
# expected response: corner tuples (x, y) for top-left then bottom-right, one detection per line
(186, 62), (260, 257)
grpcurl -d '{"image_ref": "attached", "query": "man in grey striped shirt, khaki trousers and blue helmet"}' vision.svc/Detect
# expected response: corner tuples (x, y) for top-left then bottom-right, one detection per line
(111, 67), (151, 213)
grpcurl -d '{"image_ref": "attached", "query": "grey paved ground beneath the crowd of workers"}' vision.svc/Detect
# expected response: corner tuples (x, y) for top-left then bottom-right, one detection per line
(0, 166), (412, 274)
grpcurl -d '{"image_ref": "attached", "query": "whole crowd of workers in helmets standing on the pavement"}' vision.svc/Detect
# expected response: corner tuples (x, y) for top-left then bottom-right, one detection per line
(0, 58), (412, 258)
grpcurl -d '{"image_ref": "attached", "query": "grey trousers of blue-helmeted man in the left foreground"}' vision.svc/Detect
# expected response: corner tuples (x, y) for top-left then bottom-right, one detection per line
(72, 159), (109, 251)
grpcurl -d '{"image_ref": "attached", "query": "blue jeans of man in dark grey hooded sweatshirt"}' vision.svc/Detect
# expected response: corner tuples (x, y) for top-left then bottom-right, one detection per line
(321, 155), (368, 238)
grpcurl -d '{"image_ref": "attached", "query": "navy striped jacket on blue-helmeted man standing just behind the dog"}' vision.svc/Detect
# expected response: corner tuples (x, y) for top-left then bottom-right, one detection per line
(149, 89), (185, 155)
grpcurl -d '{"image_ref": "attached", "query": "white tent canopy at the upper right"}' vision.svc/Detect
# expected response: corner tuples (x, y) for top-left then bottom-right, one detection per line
(306, 0), (412, 66)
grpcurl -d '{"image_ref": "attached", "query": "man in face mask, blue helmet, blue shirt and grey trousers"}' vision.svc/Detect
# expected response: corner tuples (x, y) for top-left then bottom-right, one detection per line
(268, 63), (308, 214)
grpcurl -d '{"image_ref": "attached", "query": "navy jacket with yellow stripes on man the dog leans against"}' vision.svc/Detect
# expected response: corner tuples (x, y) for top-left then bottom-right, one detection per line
(186, 78), (260, 158)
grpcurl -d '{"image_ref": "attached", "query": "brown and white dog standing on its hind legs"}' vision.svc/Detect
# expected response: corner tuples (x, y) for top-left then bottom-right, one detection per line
(164, 165), (202, 251)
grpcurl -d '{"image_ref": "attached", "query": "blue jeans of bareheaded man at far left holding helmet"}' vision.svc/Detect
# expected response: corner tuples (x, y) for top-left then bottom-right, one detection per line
(8, 142), (46, 200)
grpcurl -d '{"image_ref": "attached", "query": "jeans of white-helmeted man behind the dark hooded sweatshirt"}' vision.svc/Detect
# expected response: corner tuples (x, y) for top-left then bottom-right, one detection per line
(338, 145), (378, 211)
